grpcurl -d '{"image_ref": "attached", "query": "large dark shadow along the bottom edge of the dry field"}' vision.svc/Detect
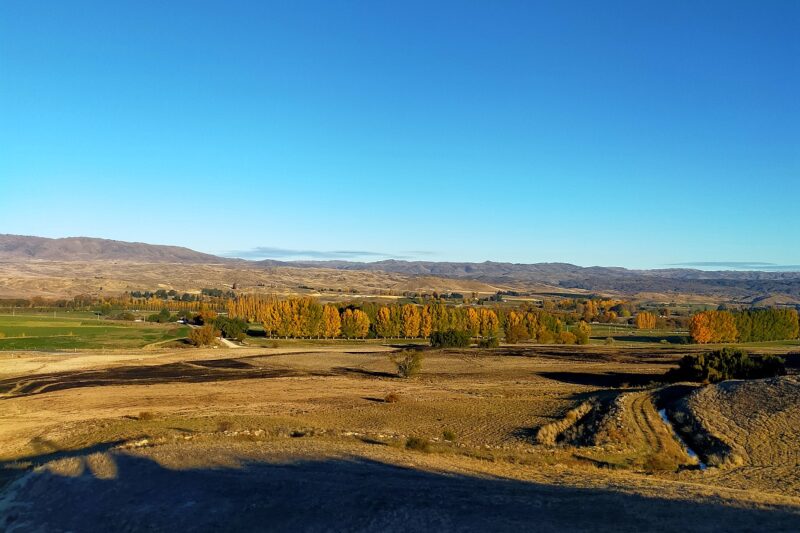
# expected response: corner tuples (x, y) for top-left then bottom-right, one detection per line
(0, 451), (800, 532)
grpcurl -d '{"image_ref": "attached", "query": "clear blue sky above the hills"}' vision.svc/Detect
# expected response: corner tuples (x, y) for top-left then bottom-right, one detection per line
(0, 0), (800, 268)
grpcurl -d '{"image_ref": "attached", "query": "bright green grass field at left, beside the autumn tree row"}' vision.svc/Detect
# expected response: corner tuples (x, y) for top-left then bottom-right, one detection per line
(0, 315), (189, 350)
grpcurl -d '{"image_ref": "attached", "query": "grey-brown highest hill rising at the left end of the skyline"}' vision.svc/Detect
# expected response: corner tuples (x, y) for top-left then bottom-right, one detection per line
(0, 235), (229, 263)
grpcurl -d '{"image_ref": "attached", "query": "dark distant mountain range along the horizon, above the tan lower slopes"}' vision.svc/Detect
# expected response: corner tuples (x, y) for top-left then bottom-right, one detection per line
(0, 235), (800, 304)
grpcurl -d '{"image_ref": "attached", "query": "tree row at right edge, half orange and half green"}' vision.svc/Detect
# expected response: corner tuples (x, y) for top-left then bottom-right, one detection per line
(689, 309), (800, 344)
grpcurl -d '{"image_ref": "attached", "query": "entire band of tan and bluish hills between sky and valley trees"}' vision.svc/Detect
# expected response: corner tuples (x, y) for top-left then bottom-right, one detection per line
(0, 235), (800, 305)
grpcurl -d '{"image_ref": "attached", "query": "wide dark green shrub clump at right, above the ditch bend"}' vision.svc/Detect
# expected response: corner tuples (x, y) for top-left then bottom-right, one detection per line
(666, 348), (786, 383)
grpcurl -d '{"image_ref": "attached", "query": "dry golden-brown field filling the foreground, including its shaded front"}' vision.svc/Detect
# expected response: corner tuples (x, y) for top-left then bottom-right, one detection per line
(0, 345), (800, 531)
